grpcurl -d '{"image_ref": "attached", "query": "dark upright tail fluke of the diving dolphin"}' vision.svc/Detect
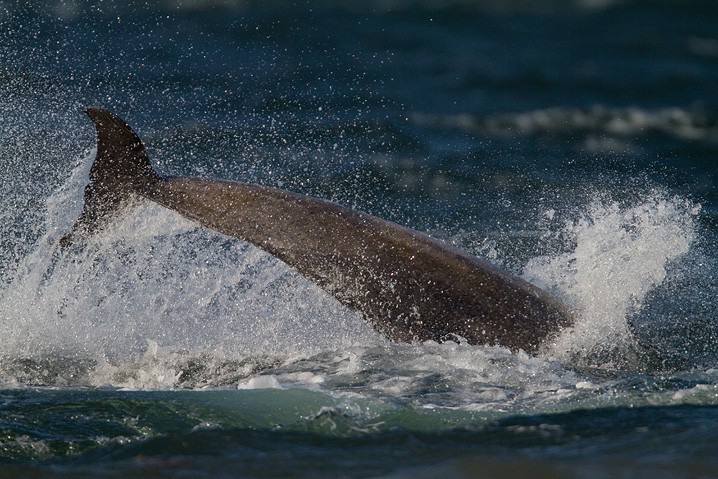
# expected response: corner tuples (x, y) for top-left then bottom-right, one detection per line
(60, 108), (161, 246)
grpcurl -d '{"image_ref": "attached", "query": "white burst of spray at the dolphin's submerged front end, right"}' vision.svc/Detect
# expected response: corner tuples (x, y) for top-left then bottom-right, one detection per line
(524, 191), (700, 361)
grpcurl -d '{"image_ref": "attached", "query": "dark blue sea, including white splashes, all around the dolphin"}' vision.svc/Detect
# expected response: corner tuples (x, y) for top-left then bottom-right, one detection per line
(0, 0), (718, 478)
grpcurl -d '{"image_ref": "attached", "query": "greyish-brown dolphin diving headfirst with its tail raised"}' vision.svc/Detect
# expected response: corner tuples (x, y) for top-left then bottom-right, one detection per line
(60, 108), (573, 353)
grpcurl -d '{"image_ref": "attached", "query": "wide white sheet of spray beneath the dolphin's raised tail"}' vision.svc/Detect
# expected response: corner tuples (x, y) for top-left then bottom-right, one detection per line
(0, 155), (383, 385)
